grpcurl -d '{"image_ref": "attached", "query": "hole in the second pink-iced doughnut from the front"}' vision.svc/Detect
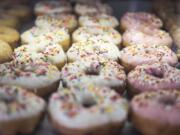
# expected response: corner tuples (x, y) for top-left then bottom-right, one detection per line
(146, 68), (164, 79)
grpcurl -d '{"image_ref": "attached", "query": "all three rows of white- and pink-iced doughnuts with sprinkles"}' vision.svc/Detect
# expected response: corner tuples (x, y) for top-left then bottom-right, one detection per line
(0, 1), (180, 135)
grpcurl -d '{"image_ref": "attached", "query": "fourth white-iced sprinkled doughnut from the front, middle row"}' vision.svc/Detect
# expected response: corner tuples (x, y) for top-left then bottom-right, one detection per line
(72, 26), (121, 46)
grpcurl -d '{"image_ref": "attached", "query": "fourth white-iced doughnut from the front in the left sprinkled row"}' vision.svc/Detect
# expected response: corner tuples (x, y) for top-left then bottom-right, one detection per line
(21, 27), (70, 51)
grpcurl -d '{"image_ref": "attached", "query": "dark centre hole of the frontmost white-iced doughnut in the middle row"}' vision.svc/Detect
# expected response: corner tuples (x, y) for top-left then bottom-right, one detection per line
(81, 95), (97, 108)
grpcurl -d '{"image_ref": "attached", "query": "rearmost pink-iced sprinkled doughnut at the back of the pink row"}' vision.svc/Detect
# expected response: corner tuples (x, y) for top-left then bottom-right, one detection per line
(120, 12), (163, 30)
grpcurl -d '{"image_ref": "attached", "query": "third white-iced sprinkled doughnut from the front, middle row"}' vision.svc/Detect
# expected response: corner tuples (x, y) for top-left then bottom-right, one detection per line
(67, 42), (120, 62)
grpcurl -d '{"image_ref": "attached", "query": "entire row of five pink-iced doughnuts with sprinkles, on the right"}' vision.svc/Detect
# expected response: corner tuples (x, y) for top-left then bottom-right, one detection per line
(120, 12), (180, 135)
